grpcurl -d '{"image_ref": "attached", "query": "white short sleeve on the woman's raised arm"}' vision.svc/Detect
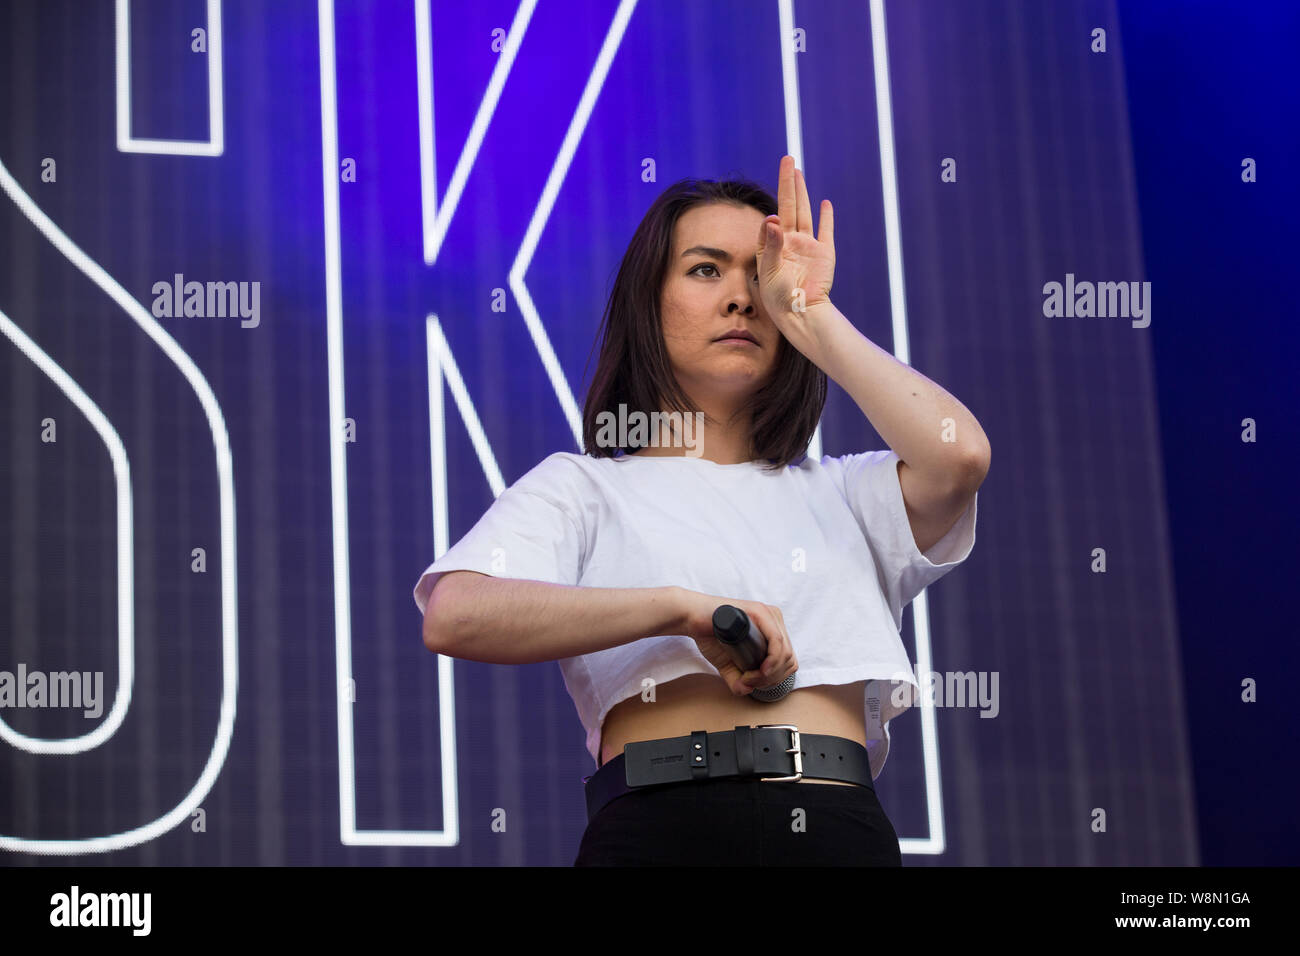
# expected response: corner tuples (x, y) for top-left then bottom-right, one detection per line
(831, 449), (979, 631)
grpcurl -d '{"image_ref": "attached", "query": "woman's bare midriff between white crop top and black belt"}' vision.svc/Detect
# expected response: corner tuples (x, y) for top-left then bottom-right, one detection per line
(601, 674), (867, 787)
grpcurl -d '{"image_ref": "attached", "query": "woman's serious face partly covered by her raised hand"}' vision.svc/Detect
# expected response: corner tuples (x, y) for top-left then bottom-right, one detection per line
(660, 203), (784, 412)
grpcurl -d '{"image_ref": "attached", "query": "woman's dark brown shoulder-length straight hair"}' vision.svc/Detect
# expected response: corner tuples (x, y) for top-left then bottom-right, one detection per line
(582, 179), (827, 471)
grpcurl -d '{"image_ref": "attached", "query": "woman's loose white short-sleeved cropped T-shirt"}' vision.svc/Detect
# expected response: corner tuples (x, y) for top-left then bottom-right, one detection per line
(415, 450), (976, 779)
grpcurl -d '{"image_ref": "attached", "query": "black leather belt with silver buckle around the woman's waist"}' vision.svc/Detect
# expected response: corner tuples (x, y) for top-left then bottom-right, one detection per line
(582, 723), (875, 821)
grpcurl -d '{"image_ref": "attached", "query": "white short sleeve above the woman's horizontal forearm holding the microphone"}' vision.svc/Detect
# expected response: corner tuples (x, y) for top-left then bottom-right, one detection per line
(415, 481), (585, 614)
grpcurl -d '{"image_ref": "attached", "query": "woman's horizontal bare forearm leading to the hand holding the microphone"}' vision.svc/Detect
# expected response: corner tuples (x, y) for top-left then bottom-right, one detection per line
(424, 571), (683, 663)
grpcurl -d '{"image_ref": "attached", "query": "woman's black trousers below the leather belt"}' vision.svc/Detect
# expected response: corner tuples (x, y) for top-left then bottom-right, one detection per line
(573, 778), (902, 866)
